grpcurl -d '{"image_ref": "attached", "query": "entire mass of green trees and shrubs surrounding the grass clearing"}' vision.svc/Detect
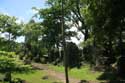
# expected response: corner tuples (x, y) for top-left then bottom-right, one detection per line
(0, 0), (125, 83)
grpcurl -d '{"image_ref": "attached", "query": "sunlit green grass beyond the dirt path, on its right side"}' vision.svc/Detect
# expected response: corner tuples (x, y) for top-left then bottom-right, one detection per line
(49, 65), (102, 81)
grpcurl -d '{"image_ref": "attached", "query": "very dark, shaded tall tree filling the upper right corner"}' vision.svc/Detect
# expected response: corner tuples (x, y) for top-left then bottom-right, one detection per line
(88, 0), (125, 77)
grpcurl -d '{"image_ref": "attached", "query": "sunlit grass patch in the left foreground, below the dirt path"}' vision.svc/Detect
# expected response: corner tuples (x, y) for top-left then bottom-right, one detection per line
(12, 70), (59, 83)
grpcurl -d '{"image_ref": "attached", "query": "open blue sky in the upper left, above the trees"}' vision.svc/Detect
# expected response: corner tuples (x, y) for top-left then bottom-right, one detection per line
(0, 0), (46, 22)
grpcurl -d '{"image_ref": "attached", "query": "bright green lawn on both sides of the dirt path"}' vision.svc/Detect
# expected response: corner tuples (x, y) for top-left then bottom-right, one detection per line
(0, 64), (106, 83)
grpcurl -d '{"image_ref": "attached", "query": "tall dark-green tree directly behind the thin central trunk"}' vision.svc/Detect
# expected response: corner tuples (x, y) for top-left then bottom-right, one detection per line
(34, 0), (76, 62)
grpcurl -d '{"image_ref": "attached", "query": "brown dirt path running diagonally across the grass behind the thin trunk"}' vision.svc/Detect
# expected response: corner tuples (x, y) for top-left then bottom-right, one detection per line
(32, 63), (80, 83)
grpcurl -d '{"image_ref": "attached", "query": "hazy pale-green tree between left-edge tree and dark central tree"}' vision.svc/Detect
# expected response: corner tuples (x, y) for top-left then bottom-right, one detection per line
(23, 19), (45, 61)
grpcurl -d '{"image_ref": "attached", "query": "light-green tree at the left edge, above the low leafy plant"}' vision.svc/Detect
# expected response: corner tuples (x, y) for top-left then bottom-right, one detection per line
(0, 14), (21, 51)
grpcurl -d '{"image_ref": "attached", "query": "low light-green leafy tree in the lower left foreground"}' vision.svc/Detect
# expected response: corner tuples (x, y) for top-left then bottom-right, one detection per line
(0, 51), (31, 82)
